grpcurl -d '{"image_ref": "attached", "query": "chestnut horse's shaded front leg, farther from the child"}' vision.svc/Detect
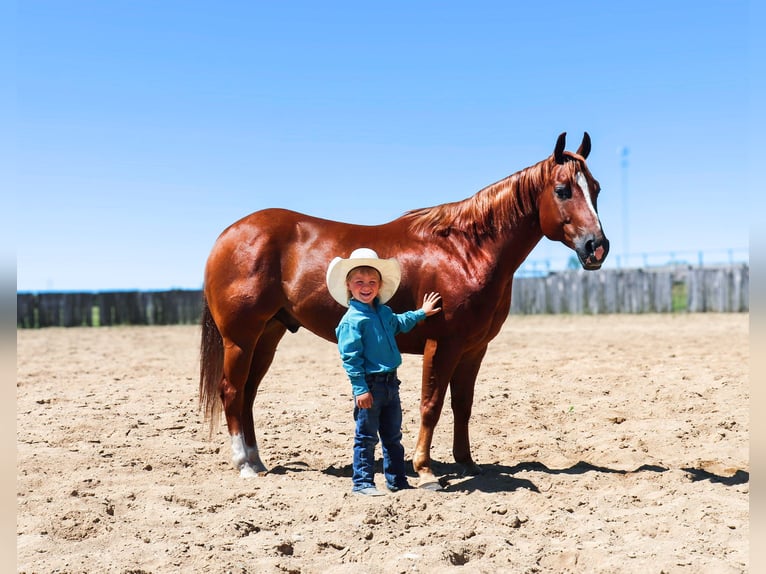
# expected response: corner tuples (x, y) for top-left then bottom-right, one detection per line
(450, 347), (486, 476)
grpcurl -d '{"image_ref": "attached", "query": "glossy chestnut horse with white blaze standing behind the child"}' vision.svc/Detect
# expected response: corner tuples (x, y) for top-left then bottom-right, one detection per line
(199, 132), (609, 490)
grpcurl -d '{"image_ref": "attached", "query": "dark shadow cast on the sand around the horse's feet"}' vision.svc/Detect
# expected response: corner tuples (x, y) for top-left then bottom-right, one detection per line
(322, 459), (750, 493)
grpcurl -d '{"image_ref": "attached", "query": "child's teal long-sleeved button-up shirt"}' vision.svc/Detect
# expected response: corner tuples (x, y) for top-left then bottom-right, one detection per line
(335, 299), (426, 396)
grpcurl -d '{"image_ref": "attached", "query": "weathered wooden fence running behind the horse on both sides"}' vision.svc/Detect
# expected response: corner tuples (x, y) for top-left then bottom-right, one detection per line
(16, 265), (750, 328)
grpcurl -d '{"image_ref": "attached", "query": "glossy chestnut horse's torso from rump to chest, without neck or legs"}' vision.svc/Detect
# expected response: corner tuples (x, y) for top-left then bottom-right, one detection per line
(205, 208), (510, 354)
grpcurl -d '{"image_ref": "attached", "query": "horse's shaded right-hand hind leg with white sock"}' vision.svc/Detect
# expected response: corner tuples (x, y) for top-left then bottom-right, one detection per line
(230, 321), (285, 478)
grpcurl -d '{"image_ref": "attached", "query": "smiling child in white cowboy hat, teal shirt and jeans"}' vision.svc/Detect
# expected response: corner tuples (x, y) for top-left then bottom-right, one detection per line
(327, 248), (441, 496)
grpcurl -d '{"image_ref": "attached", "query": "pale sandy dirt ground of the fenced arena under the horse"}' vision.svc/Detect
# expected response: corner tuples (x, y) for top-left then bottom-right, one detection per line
(16, 314), (750, 574)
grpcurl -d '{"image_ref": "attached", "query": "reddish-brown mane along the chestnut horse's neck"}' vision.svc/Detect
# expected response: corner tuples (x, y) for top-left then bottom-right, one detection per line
(403, 156), (551, 241)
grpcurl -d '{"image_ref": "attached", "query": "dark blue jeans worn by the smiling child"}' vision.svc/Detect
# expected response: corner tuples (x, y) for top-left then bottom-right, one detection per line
(353, 375), (408, 490)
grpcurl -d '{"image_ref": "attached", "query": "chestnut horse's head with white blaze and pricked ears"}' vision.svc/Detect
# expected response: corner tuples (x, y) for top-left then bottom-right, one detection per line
(538, 132), (609, 270)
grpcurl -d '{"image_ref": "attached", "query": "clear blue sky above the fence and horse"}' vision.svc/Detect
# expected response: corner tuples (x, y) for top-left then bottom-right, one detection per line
(10, 0), (755, 291)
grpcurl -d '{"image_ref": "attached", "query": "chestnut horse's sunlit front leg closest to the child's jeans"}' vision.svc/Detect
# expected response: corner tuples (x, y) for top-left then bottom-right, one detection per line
(412, 339), (451, 490)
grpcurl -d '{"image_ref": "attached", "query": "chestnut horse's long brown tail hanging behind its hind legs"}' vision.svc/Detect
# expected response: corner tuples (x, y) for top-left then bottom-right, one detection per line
(199, 298), (223, 437)
